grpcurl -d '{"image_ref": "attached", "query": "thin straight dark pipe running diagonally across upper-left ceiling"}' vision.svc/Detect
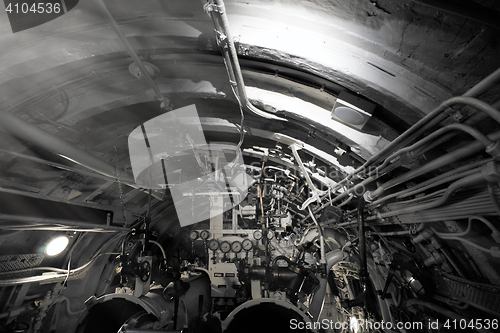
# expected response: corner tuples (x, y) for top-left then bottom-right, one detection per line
(94, 0), (170, 108)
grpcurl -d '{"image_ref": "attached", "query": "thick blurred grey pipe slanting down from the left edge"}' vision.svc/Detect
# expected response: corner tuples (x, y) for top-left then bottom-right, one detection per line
(0, 111), (135, 183)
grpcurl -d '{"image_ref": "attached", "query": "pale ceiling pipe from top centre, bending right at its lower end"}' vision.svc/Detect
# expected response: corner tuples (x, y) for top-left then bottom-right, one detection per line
(206, 0), (287, 121)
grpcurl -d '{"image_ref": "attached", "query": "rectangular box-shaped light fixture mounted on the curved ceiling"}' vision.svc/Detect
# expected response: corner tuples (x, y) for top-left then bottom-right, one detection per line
(331, 91), (375, 129)
